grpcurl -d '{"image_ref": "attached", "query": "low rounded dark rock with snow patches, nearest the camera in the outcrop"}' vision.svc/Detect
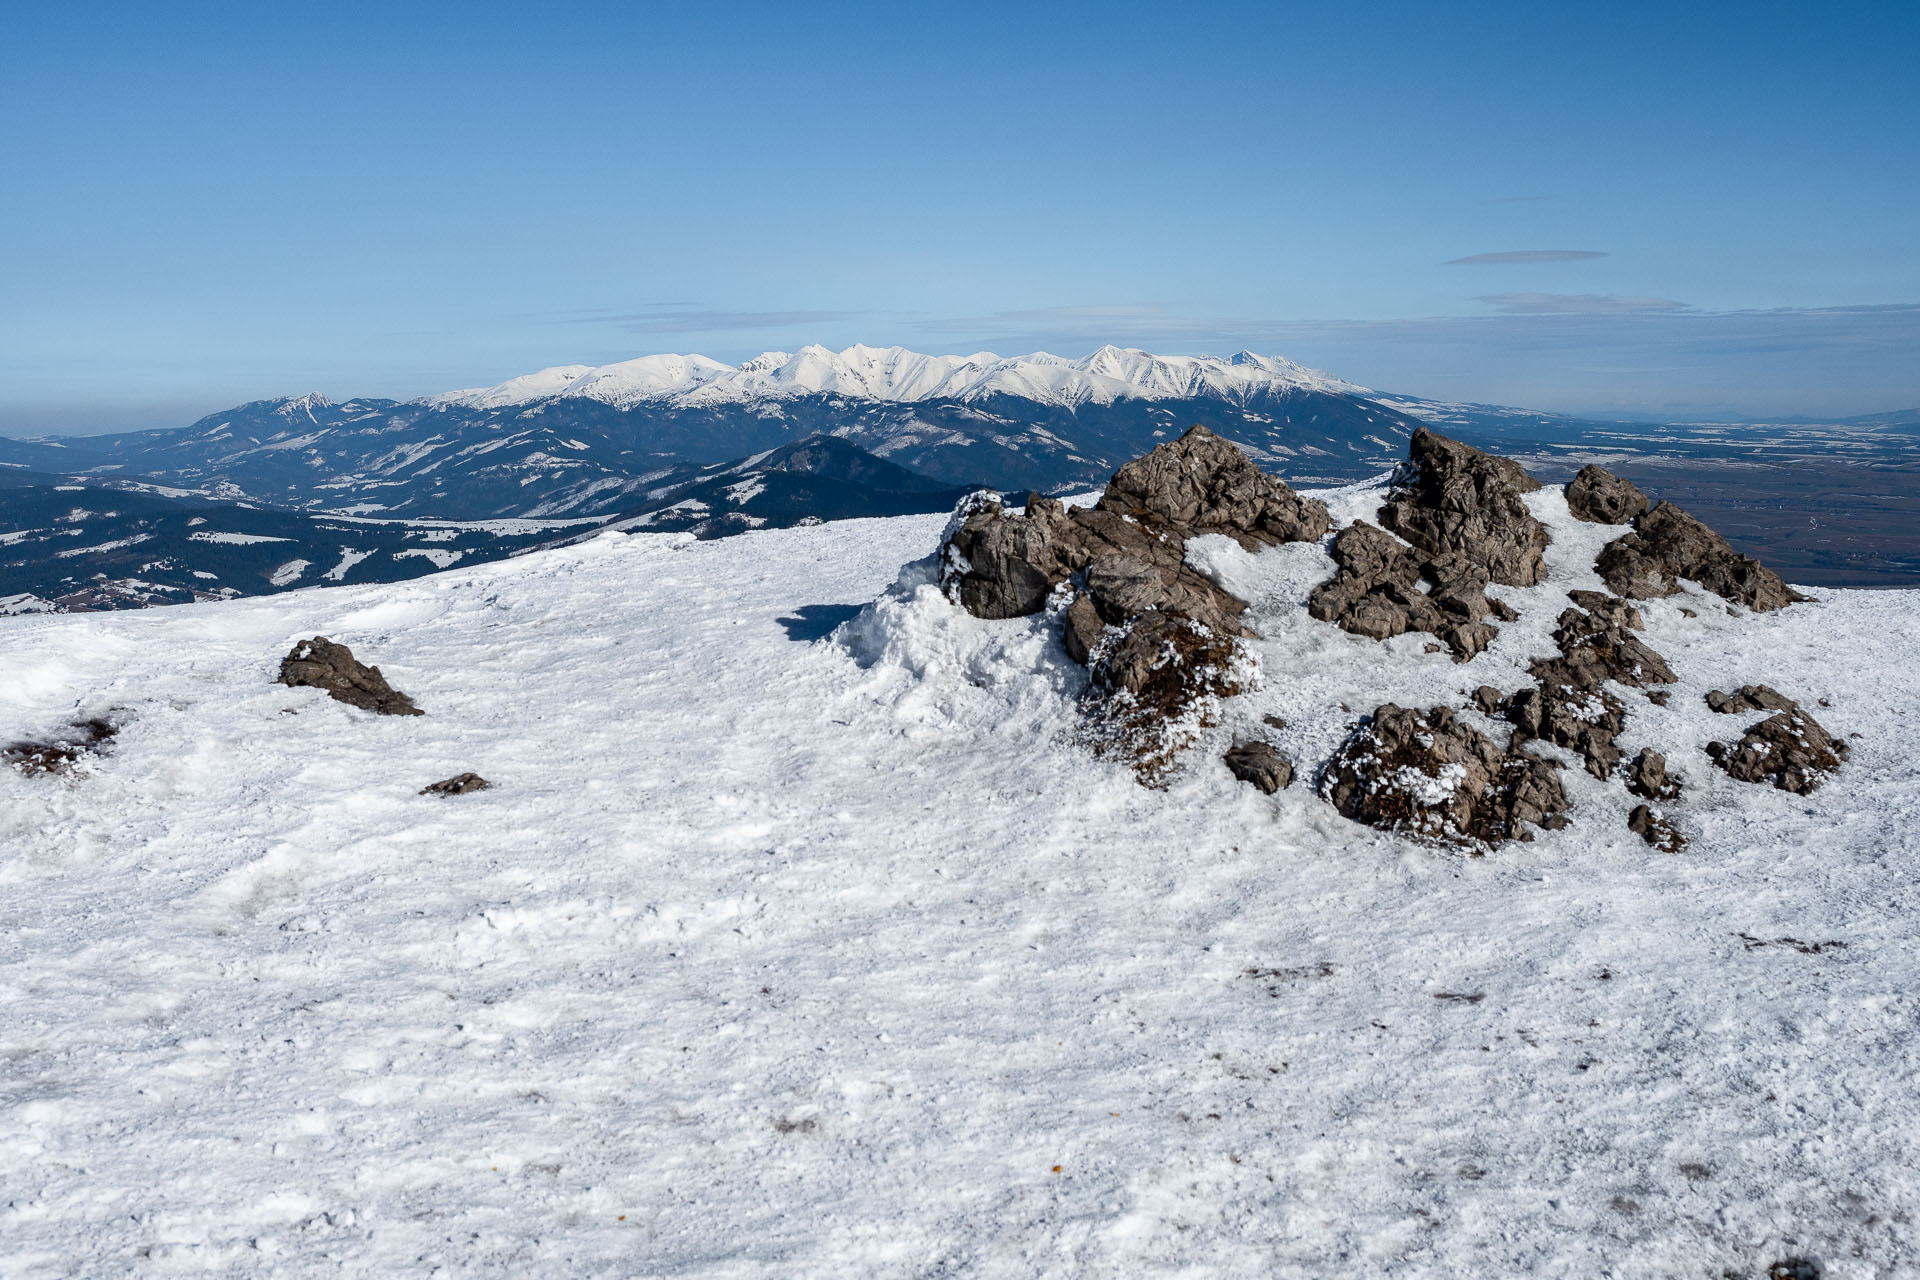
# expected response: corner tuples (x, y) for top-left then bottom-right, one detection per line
(1319, 702), (1567, 844)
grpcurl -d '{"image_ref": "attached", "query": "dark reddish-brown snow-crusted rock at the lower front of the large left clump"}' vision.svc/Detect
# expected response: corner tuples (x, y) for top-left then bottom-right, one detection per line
(1081, 612), (1260, 787)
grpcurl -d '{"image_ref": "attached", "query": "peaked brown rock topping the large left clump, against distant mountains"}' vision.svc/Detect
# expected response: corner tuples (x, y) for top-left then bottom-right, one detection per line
(1098, 426), (1332, 551)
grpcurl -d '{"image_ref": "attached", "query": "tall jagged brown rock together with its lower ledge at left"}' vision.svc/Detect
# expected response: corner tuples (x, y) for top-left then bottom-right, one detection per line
(1308, 430), (1548, 662)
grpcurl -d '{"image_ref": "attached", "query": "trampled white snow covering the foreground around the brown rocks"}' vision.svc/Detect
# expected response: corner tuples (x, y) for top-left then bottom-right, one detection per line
(0, 489), (1920, 1280)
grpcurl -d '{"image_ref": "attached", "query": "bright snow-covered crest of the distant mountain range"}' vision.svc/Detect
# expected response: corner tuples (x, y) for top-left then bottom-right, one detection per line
(424, 345), (1371, 409)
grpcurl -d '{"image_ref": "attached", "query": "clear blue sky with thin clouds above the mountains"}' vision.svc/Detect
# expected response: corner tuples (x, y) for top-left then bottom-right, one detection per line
(0, 4), (1920, 434)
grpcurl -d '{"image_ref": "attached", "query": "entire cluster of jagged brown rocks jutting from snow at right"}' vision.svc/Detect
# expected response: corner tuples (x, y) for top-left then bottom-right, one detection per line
(921, 416), (1845, 825)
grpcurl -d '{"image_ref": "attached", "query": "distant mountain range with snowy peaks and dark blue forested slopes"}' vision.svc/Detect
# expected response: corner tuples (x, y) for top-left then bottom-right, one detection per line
(0, 345), (1419, 520)
